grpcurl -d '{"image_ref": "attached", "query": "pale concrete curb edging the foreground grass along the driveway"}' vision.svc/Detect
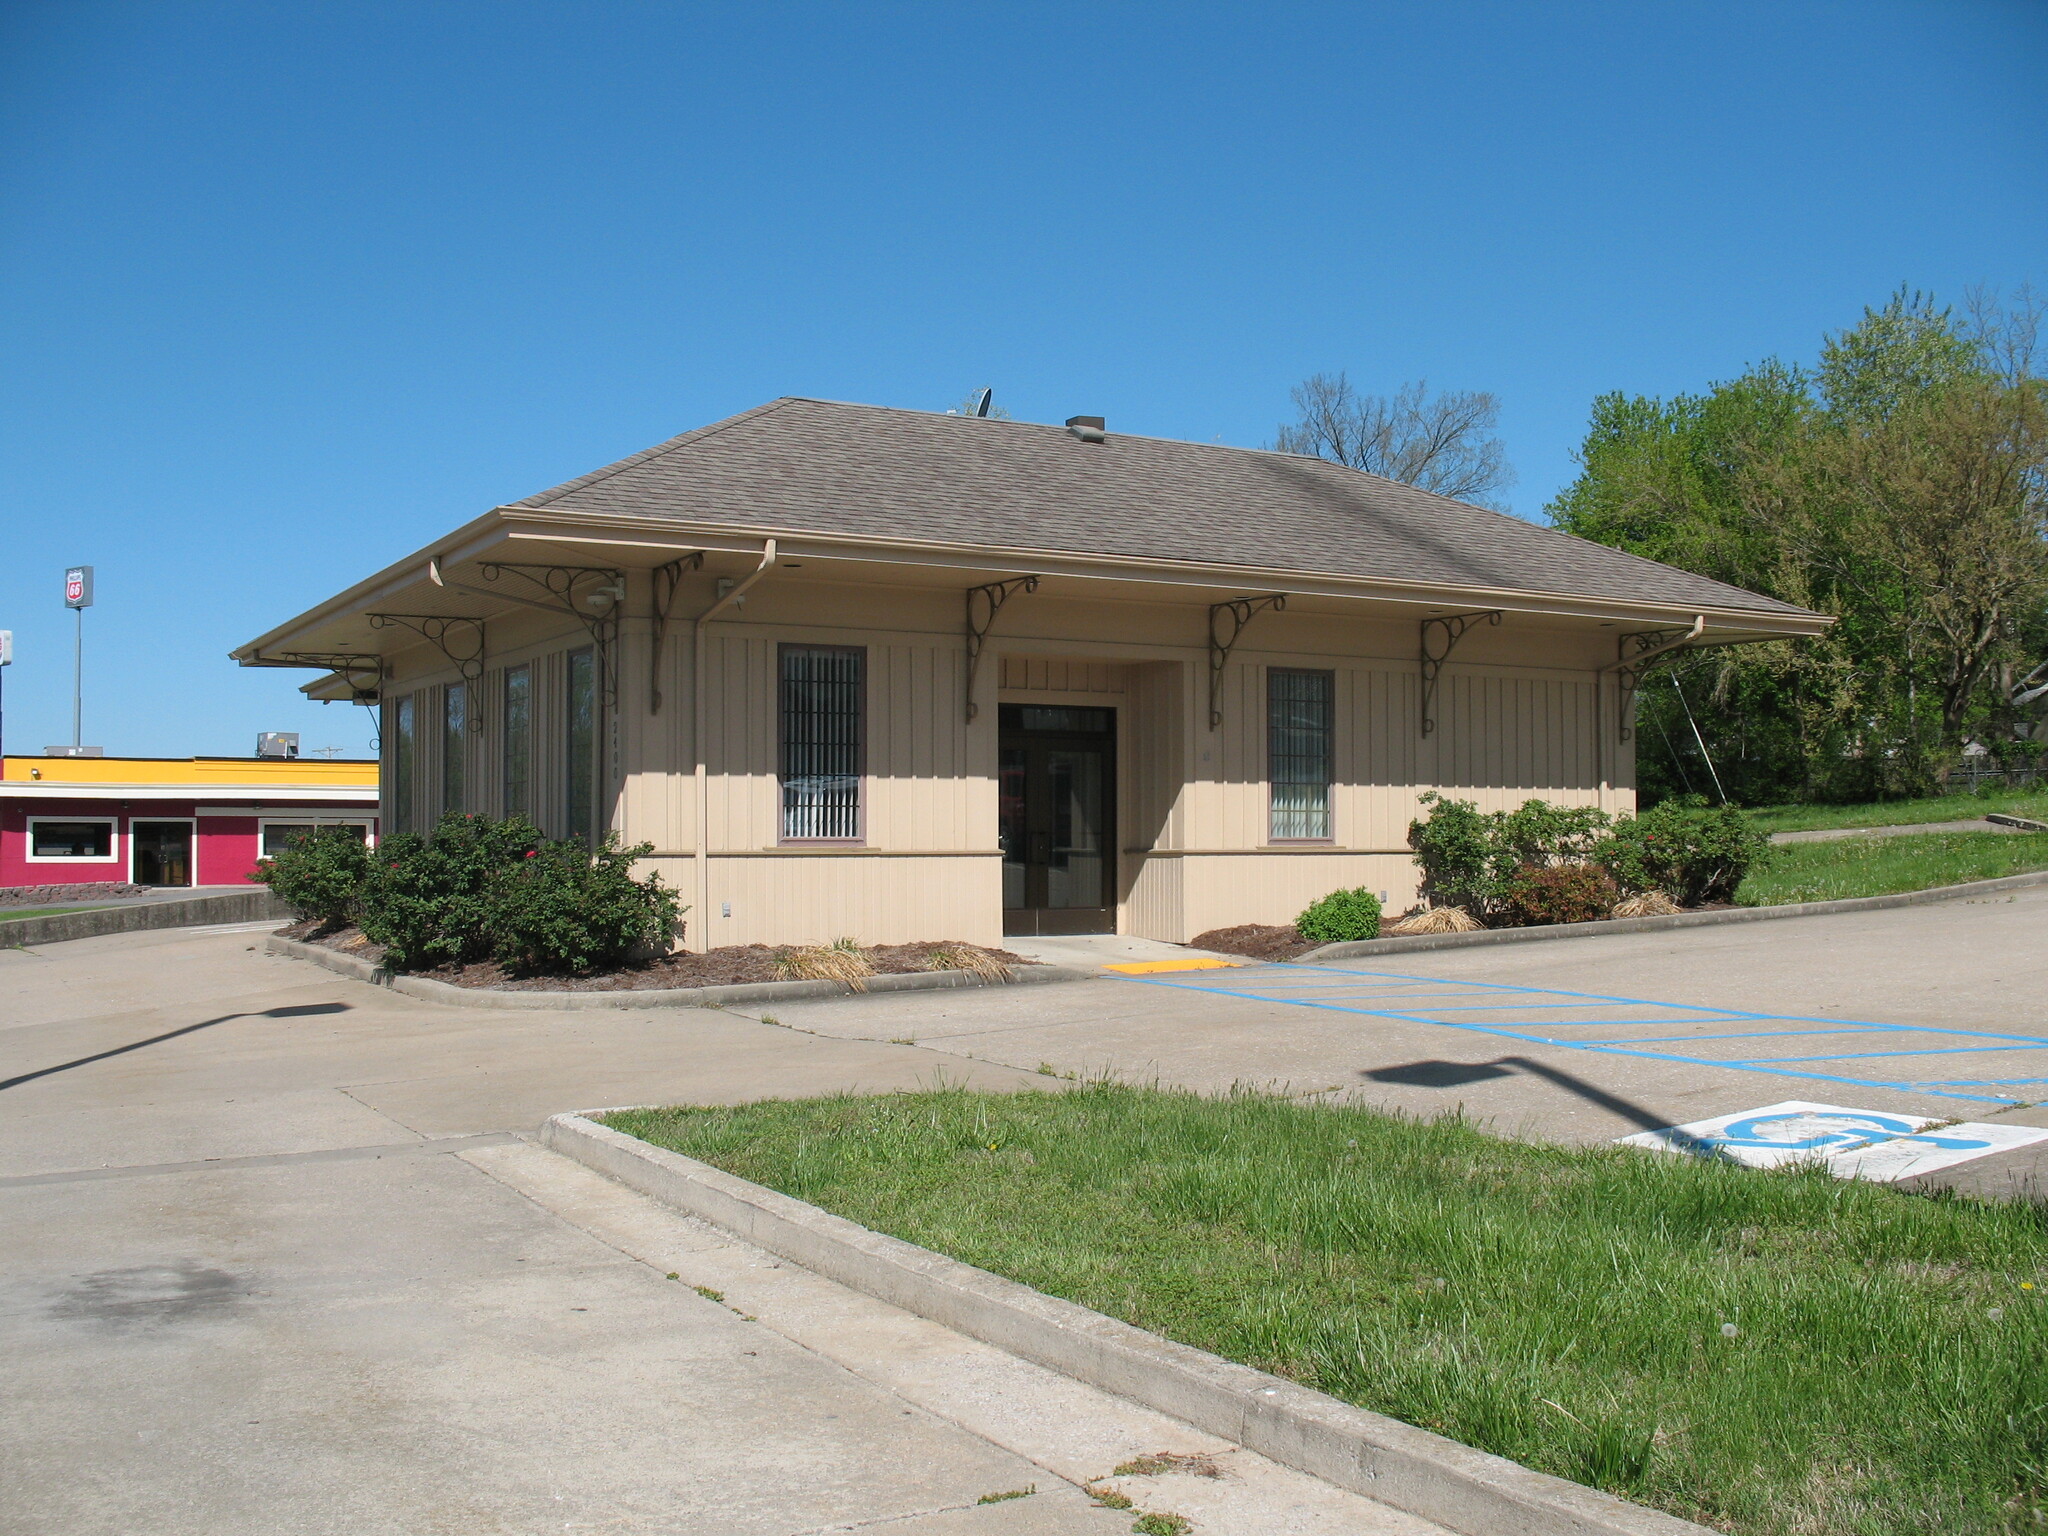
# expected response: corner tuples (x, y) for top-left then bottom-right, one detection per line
(541, 1114), (1708, 1536)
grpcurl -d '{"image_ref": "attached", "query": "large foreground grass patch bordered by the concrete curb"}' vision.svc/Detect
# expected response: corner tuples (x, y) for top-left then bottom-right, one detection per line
(606, 1083), (2048, 1536)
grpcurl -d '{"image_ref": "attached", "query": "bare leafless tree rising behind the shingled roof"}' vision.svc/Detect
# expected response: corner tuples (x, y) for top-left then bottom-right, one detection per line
(1274, 373), (1516, 512)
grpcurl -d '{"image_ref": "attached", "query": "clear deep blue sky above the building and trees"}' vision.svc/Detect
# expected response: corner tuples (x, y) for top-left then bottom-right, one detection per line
(0, 0), (2048, 756)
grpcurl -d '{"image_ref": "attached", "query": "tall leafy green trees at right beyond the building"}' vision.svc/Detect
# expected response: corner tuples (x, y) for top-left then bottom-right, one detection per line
(1550, 289), (2048, 803)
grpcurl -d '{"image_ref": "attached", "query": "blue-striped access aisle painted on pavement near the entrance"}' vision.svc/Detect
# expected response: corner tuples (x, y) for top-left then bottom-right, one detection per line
(1122, 965), (2048, 1104)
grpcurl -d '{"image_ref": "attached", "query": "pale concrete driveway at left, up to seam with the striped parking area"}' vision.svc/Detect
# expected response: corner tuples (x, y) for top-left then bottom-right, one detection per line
(0, 932), (1436, 1536)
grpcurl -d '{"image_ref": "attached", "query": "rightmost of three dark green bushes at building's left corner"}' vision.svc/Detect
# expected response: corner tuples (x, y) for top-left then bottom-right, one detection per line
(487, 834), (682, 973)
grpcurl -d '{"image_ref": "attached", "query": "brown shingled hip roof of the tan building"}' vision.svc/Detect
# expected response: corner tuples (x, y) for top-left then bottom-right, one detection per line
(518, 397), (1804, 614)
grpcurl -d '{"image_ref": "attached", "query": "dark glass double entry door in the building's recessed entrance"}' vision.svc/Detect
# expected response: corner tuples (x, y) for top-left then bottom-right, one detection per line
(997, 705), (1116, 936)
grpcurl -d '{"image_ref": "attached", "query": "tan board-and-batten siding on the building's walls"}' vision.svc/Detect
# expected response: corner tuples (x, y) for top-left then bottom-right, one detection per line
(364, 573), (1632, 948)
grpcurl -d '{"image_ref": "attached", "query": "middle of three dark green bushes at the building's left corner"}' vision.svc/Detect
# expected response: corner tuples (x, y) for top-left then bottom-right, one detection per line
(358, 811), (547, 971)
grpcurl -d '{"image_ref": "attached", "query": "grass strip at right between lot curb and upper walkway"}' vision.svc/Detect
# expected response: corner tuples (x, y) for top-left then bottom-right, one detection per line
(1735, 831), (2048, 907)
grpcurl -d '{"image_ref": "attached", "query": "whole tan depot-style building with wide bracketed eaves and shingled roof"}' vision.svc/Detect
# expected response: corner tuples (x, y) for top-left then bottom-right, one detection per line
(233, 399), (1829, 948)
